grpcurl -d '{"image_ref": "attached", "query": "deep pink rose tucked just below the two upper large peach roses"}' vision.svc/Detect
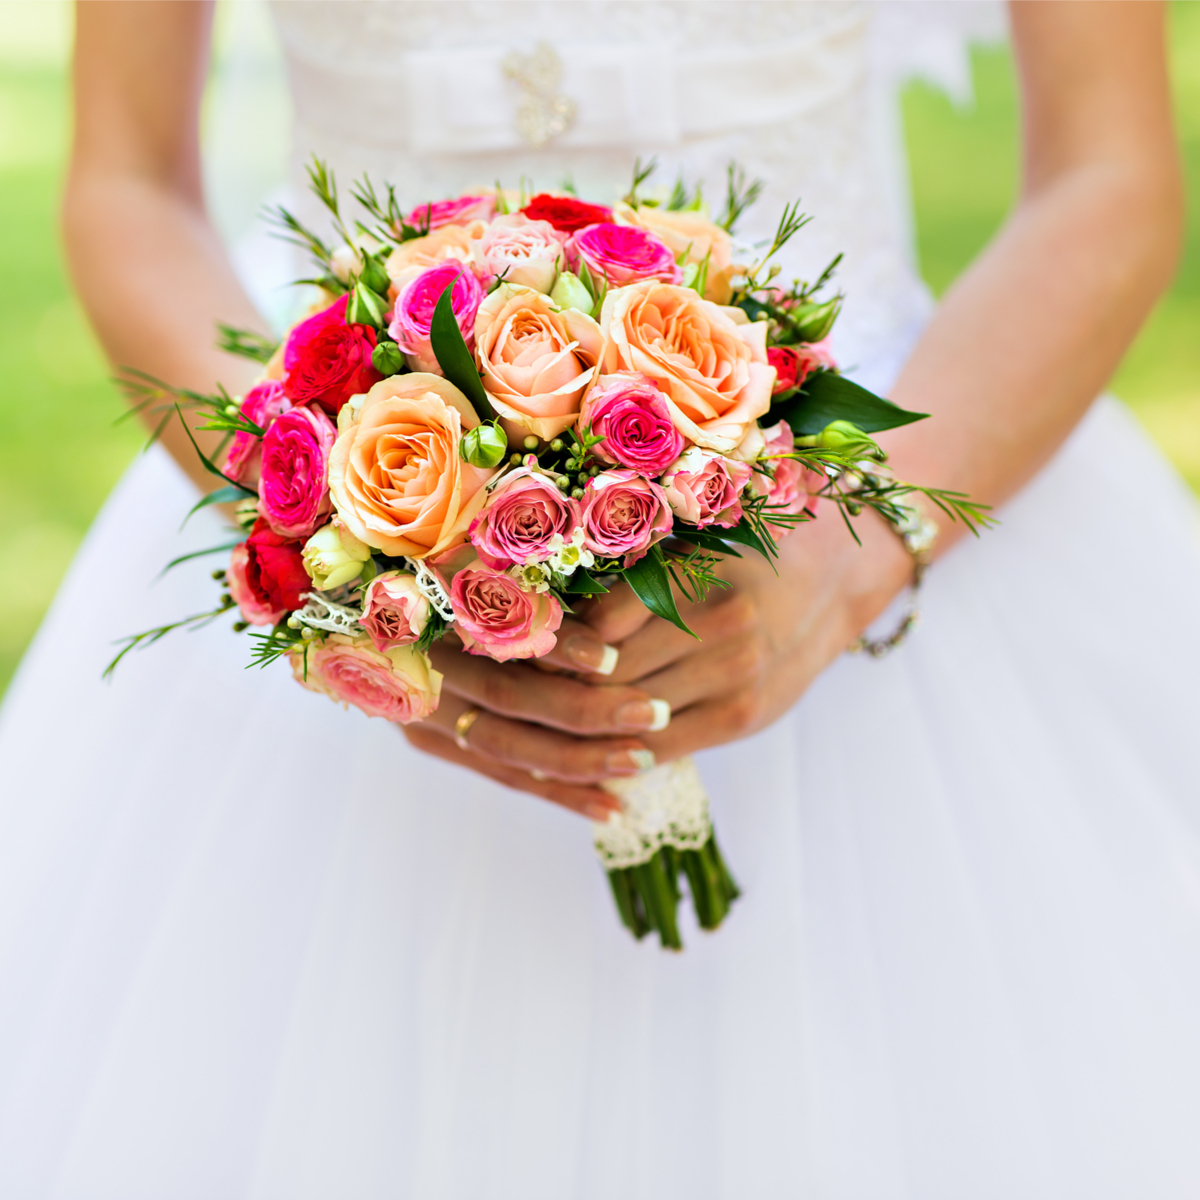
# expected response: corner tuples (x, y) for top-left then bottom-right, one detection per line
(580, 372), (686, 475)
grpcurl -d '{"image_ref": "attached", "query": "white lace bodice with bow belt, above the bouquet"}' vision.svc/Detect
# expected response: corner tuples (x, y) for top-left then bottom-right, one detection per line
(260, 0), (1003, 383)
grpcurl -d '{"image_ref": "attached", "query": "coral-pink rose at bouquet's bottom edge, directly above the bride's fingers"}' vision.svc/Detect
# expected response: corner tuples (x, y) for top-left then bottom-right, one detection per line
(450, 559), (563, 662)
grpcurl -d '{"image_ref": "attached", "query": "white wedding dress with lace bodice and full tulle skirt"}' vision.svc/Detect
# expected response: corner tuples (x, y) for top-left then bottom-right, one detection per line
(0, 2), (1200, 1200)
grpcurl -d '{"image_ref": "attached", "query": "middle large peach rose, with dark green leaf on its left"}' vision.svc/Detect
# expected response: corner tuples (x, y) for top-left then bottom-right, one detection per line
(475, 283), (600, 440)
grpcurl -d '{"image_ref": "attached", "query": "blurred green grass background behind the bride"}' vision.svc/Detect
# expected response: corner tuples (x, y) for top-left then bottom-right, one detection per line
(0, 0), (1200, 690)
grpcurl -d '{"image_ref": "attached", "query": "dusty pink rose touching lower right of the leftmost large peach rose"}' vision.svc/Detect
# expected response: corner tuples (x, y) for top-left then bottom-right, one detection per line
(470, 467), (580, 571)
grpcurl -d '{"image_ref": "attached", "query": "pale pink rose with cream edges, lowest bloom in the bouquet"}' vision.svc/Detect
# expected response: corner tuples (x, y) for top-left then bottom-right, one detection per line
(292, 634), (442, 725)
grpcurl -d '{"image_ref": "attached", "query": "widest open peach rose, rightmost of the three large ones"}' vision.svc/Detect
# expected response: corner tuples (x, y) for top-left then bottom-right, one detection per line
(600, 280), (775, 454)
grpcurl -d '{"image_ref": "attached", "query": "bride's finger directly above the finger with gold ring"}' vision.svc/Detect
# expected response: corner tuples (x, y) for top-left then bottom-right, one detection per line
(430, 646), (671, 737)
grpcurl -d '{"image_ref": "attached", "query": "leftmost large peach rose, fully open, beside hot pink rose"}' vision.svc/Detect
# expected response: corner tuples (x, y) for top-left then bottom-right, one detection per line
(329, 372), (493, 558)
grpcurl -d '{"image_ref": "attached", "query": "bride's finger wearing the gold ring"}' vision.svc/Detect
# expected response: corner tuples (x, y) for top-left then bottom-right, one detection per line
(422, 695), (654, 784)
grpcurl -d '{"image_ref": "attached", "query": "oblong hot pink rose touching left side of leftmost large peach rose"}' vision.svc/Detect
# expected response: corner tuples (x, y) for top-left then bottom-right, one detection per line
(258, 404), (337, 538)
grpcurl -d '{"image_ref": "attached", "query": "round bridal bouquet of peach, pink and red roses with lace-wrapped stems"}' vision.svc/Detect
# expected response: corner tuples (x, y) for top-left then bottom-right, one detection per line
(109, 163), (978, 948)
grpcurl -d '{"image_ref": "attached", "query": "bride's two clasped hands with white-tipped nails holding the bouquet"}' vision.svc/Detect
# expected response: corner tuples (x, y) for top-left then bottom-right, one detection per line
(404, 512), (912, 820)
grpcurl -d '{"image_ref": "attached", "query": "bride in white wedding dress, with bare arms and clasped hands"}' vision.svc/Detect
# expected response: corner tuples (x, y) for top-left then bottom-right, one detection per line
(0, 2), (1200, 1200)
